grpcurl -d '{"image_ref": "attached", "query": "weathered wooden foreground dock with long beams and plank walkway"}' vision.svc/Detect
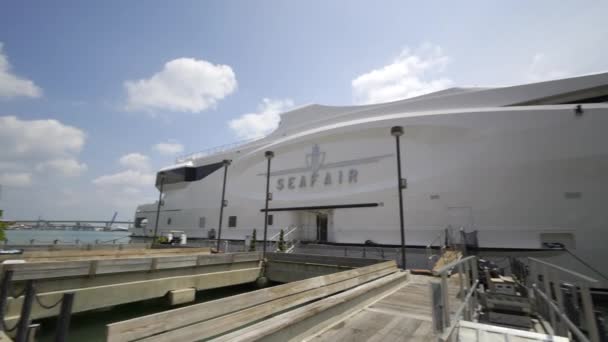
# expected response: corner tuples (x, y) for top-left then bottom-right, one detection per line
(107, 255), (567, 342)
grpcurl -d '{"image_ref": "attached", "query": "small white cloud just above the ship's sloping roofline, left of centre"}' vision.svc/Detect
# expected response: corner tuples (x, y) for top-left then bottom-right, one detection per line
(228, 98), (294, 139)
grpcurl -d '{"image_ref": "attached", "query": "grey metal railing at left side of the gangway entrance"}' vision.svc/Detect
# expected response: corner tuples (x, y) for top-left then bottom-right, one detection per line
(429, 256), (479, 341)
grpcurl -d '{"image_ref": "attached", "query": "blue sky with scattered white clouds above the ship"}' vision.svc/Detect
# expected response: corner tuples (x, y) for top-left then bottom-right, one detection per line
(0, 1), (608, 219)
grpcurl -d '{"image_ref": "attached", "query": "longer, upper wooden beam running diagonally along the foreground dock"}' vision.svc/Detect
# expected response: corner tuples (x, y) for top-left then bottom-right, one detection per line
(106, 261), (398, 342)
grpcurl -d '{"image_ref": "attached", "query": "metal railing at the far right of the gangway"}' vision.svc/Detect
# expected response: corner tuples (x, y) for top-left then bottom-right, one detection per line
(528, 258), (600, 342)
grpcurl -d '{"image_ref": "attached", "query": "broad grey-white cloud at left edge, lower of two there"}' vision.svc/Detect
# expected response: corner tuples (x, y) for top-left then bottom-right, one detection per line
(0, 116), (87, 184)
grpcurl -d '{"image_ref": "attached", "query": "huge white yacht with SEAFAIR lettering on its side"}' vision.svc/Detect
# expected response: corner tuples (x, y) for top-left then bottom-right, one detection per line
(132, 73), (608, 284)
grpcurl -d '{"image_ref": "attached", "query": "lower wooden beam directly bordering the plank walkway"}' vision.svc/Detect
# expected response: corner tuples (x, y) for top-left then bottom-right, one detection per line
(211, 271), (409, 342)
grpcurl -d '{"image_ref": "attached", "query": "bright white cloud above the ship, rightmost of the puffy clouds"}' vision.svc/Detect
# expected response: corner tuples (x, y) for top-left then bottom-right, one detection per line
(351, 44), (453, 104)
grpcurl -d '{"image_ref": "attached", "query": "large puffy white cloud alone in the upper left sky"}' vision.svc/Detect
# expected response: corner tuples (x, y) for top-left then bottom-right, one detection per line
(124, 58), (237, 113)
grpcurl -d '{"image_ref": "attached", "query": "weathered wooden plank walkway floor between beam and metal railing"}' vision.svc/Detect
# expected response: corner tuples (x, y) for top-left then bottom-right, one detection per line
(306, 275), (460, 342)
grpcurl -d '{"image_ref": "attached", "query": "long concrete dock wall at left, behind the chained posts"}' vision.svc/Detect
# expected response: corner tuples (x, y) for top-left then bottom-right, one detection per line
(3, 252), (261, 324)
